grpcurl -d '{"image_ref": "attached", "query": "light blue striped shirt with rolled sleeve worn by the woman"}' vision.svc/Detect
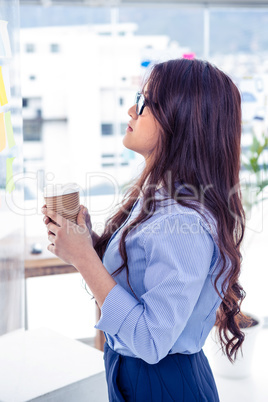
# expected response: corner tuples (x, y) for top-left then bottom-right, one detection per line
(95, 189), (225, 364)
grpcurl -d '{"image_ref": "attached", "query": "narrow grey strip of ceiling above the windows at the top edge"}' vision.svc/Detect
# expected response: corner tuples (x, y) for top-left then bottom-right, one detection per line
(20, 0), (268, 7)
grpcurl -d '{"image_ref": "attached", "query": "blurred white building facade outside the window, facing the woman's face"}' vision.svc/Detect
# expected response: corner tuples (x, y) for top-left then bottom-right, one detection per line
(21, 24), (189, 196)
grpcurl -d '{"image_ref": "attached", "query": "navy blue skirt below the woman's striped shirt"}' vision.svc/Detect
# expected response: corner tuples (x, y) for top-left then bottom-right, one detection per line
(104, 342), (219, 402)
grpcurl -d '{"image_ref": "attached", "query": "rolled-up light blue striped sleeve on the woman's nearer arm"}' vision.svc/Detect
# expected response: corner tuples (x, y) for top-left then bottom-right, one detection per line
(96, 214), (214, 364)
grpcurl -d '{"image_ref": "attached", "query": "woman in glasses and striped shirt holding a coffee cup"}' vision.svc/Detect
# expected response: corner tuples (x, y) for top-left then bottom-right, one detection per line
(43, 59), (247, 402)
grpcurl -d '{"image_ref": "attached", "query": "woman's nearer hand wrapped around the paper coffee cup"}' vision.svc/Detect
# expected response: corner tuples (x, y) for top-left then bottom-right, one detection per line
(41, 205), (93, 266)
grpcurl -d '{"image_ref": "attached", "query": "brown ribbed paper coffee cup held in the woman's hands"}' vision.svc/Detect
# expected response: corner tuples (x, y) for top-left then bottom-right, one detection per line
(44, 183), (80, 223)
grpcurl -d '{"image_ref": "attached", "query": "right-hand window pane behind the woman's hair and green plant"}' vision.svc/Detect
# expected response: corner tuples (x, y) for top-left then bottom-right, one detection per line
(210, 8), (268, 317)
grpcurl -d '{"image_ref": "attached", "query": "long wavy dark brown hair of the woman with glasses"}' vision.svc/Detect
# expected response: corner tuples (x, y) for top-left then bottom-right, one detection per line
(95, 59), (245, 361)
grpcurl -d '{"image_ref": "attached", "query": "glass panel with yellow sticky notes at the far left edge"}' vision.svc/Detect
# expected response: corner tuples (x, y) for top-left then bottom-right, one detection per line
(0, 0), (24, 335)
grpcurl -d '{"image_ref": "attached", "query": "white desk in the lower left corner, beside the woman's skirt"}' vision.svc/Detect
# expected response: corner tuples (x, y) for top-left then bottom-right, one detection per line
(0, 328), (108, 402)
